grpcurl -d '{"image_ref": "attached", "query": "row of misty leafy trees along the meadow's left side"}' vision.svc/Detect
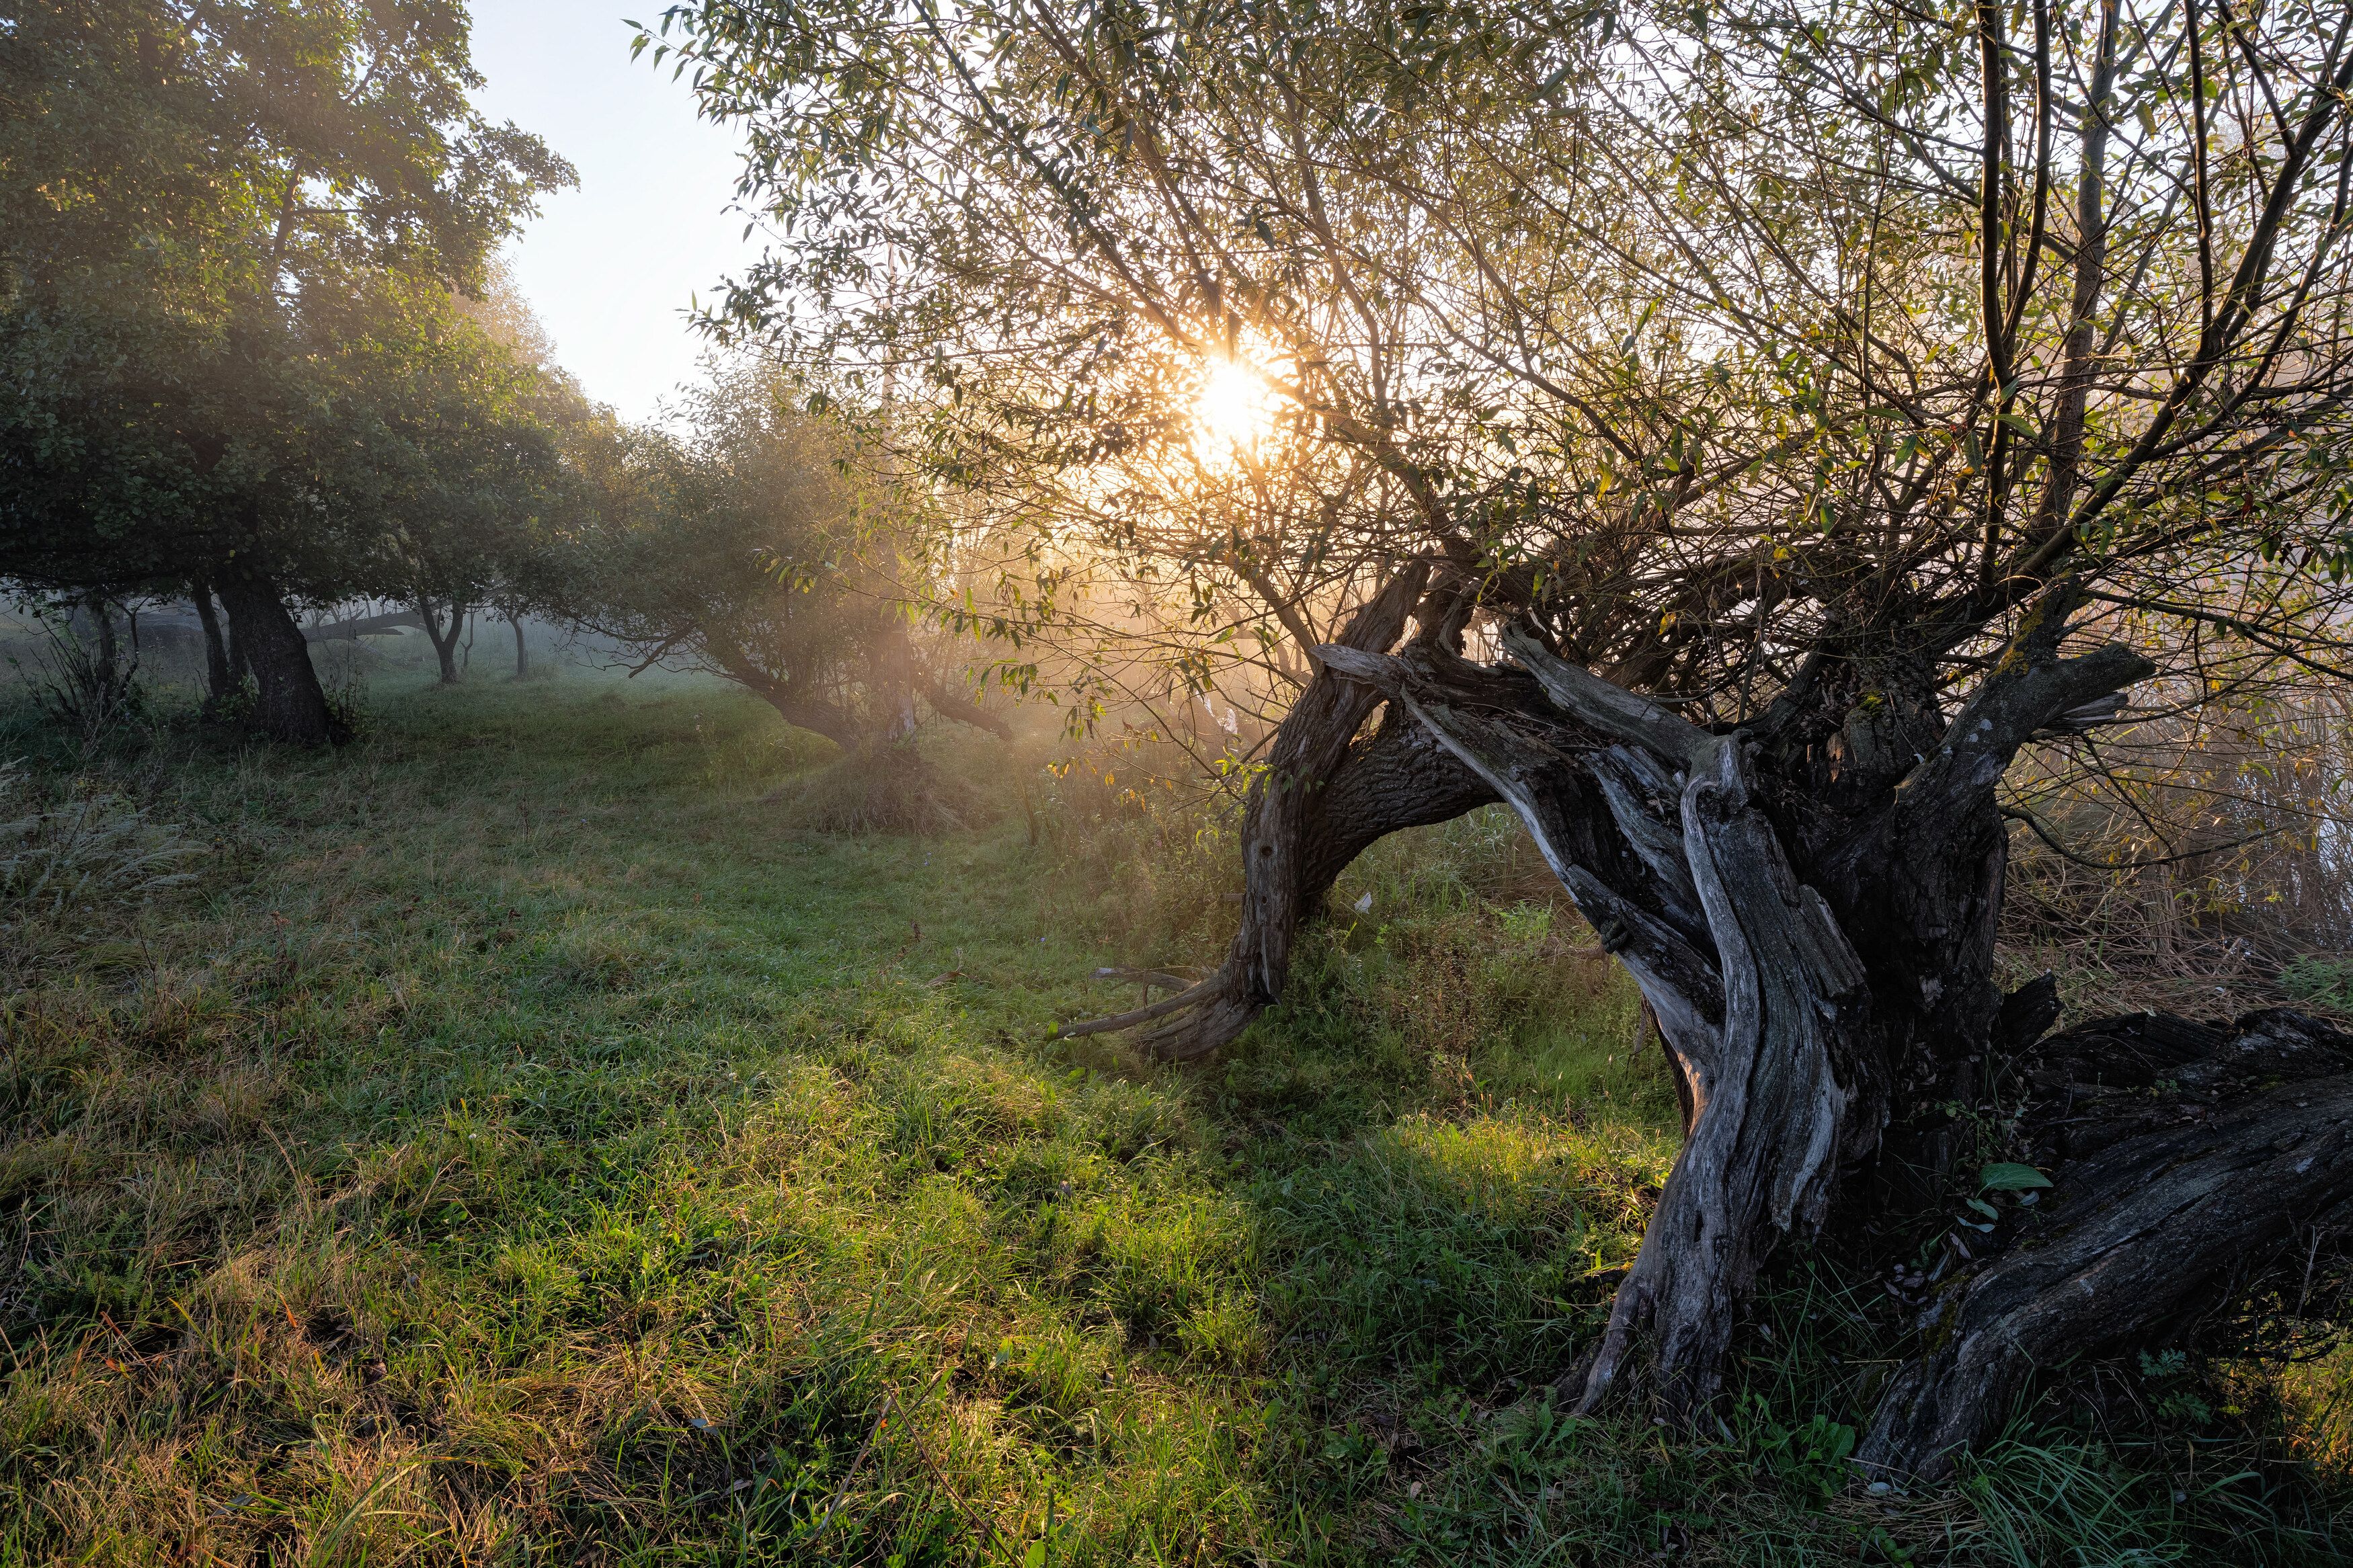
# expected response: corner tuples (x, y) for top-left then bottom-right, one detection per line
(0, 0), (996, 743)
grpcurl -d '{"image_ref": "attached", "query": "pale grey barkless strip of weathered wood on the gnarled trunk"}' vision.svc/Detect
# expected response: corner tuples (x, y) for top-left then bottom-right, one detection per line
(1322, 637), (1887, 1422)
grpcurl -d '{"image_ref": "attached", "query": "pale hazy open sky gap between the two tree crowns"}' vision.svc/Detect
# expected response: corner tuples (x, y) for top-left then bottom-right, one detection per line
(473, 0), (760, 419)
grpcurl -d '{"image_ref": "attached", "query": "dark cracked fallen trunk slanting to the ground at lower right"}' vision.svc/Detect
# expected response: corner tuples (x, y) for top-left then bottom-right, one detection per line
(1859, 1014), (2353, 1481)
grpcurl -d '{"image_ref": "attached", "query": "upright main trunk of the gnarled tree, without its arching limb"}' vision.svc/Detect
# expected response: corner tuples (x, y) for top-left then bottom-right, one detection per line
(1320, 587), (2149, 1427)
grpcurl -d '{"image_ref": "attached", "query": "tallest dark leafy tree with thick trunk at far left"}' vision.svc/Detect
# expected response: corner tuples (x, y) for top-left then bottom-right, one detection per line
(0, 0), (572, 741)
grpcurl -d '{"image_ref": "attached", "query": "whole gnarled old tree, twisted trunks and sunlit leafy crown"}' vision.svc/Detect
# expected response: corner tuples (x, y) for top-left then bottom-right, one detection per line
(647, 0), (2353, 1474)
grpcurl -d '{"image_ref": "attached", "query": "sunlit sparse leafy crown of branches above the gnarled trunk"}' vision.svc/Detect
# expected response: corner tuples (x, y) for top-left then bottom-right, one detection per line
(654, 2), (2353, 717)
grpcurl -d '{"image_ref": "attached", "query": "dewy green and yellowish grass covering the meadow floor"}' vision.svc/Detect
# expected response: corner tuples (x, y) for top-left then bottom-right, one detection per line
(0, 672), (2323, 1568)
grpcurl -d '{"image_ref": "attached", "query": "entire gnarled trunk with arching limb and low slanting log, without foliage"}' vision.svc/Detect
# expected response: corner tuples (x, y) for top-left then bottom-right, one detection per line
(1068, 583), (2353, 1477)
